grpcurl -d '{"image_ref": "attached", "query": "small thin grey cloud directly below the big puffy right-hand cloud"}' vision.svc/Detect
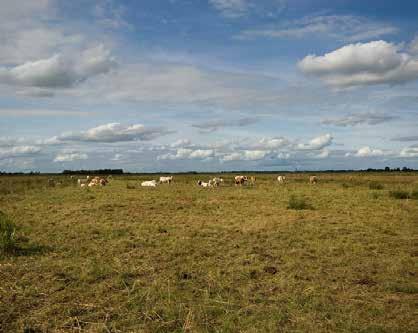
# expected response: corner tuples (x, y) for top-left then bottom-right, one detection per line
(321, 112), (399, 127)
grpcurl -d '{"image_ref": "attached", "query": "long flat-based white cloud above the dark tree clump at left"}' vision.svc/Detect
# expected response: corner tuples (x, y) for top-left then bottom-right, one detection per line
(58, 123), (173, 142)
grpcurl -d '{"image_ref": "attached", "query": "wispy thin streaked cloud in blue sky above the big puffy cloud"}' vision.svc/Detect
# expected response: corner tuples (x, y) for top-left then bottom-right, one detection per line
(238, 15), (398, 42)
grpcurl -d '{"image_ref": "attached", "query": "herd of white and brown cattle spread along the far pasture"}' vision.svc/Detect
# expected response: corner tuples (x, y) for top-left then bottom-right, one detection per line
(54, 175), (318, 188)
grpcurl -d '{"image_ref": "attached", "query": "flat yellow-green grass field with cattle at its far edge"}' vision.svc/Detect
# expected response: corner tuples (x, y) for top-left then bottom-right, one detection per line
(0, 173), (418, 333)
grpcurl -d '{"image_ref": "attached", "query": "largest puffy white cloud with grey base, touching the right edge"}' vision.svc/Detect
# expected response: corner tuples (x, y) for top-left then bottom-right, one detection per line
(298, 40), (418, 87)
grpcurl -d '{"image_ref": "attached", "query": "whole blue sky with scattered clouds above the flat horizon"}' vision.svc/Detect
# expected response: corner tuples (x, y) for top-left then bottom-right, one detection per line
(0, 0), (418, 172)
